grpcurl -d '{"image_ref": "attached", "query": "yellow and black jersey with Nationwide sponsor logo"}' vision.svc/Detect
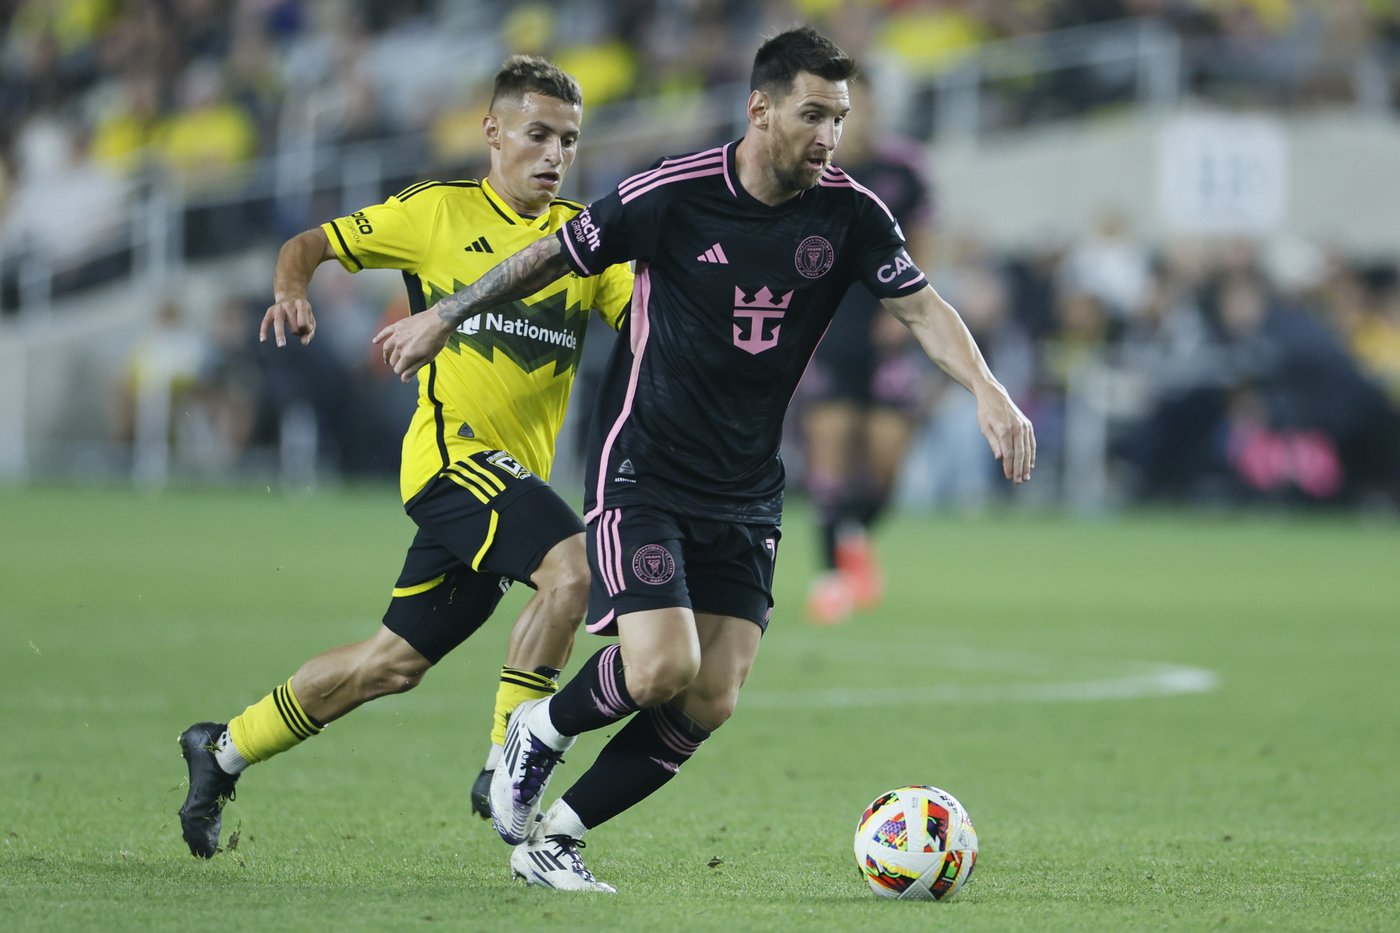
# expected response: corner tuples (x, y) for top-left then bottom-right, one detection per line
(322, 179), (633, 502)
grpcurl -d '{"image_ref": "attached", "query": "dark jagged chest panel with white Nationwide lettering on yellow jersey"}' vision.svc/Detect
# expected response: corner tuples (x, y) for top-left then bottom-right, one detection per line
(428, 282), (588, 375)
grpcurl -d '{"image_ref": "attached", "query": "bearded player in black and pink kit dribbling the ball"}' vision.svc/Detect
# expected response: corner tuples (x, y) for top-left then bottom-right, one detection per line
(375, 28), (1035, 891)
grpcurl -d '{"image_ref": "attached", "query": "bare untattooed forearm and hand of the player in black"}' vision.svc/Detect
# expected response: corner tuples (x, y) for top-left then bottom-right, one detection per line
(882, 287), (1036, 483)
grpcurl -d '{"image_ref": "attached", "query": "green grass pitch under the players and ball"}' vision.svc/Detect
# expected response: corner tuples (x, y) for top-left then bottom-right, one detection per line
(0, 488), (1400, 930)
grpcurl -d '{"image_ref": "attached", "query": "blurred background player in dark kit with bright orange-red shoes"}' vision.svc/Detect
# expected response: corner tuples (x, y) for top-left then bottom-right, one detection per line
(801, 81), (932, 625)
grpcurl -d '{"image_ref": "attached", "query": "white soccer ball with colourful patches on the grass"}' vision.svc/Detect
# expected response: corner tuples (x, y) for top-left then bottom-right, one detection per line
(855, 785), (977, 901)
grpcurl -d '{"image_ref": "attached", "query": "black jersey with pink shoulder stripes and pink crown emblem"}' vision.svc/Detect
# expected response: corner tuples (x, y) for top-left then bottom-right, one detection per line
(557, 143), (927, 523)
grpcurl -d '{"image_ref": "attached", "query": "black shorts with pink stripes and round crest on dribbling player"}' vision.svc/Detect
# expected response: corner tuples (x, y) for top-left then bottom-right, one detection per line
(587, 506), (783, 635)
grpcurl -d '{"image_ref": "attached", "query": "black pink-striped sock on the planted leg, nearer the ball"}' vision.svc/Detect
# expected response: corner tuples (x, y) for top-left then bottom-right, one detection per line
(563, 703), (710, 829)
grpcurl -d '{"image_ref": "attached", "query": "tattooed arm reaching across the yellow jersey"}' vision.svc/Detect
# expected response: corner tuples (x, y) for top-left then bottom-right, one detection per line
(374, 237), (568, 382)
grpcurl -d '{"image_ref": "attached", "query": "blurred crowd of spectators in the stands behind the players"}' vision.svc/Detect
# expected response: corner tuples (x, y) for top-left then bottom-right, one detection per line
(8, 0), (1400, 504)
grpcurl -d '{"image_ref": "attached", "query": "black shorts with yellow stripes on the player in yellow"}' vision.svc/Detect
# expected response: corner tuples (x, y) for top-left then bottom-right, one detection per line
(384, 451), (584, 664)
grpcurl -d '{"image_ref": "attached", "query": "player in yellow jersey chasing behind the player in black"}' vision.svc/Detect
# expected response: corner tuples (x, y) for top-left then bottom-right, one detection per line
(179, 56), (633, 859)
